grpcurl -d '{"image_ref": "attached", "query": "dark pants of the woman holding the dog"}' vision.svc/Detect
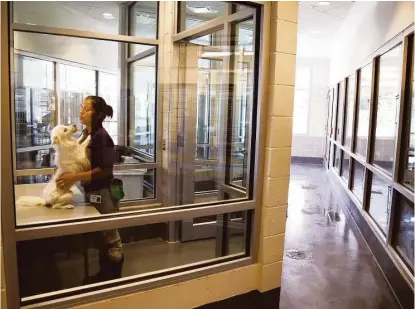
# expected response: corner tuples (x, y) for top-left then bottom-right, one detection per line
(85, 188), (123, 262)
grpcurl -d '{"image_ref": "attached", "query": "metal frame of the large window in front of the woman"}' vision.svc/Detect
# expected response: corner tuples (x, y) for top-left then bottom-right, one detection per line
(0, 2), (271, 308)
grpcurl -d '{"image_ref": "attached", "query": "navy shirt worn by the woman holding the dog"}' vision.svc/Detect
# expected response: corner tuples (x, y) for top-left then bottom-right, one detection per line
(81, 125), (115, 191)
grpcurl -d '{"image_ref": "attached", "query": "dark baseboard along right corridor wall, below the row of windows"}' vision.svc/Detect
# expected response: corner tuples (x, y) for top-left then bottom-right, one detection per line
(328, 171), (414, 309)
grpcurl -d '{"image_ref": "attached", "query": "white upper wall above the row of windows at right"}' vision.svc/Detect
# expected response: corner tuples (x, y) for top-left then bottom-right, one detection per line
(330, 1), (414, 84)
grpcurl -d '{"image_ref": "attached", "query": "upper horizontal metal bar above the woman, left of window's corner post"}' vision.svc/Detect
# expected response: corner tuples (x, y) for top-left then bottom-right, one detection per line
(12, 22), (160, 45)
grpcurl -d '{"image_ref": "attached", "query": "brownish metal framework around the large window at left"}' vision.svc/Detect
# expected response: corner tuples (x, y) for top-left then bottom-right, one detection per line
(0, 2), (271, 308)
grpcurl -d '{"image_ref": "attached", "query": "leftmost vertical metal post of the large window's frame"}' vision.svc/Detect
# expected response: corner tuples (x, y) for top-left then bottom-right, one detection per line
(0, 2), (20, 309)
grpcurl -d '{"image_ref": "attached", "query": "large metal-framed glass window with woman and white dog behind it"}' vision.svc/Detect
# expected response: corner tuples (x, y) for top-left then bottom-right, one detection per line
(2, 1), (263, 306)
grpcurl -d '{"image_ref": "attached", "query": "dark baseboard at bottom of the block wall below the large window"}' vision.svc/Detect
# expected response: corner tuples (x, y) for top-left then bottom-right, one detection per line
(197, 287), (281, 309)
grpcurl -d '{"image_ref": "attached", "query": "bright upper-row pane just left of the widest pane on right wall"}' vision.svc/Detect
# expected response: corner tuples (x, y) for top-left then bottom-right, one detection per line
(356, 64), (372, 157)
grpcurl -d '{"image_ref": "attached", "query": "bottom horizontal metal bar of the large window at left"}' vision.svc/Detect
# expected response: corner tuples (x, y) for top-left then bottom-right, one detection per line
(24, 254), (252, 309)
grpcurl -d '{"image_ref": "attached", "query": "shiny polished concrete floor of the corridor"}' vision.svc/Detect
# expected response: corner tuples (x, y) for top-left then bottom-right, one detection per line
(280, 164), (400, 309)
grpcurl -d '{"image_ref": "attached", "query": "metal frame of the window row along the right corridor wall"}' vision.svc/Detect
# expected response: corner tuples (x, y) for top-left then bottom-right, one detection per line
(330, 24), (415, 288)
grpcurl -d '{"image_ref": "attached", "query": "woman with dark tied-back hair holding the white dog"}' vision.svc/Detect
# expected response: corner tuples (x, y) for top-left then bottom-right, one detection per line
(57, 96), (124, 282)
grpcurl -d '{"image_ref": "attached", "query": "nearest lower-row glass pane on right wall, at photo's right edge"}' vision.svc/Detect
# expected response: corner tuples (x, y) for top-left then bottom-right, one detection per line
(393, 195), (415, 272)
